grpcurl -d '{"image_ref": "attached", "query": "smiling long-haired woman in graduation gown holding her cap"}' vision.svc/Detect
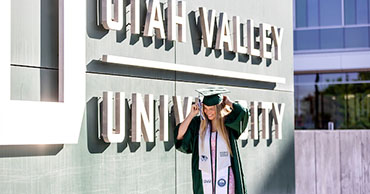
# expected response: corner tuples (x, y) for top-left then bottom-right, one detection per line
(175, 90), (249, 194)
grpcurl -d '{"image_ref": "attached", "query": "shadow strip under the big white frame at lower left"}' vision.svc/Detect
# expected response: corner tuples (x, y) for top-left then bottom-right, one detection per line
(0, 144), (64, 158)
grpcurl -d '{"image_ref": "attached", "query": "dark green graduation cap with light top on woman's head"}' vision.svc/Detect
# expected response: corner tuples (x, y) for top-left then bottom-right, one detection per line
(195, 87), (230, 106)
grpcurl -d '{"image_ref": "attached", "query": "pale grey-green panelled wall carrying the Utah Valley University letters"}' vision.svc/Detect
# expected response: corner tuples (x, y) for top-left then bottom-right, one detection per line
(0, 0), (295, 194)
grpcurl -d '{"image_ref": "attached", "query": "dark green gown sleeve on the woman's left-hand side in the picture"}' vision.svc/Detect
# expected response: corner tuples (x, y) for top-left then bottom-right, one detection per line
(174, 116), (200, 154)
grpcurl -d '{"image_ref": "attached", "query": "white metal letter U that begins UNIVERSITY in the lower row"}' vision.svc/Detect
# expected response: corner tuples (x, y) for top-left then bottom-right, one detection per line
(102, 92), (126, 143)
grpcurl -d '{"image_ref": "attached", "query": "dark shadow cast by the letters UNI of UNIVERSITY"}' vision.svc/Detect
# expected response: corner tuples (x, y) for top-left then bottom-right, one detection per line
(86, 97), (175, 154)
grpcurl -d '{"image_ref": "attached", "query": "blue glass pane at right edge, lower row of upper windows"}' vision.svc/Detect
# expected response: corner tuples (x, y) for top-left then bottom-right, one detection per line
(344, 27), (369, 48)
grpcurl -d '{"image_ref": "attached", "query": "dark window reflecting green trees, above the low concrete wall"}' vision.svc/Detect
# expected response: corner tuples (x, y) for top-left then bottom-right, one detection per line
(294, 72), (370, 129)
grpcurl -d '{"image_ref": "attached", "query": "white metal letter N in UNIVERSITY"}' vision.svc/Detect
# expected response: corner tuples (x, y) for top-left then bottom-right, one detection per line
(131, 93), (154, 142)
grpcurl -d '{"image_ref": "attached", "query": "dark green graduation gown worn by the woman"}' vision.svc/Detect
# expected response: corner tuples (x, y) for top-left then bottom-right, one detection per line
(175, 103), (249, 194)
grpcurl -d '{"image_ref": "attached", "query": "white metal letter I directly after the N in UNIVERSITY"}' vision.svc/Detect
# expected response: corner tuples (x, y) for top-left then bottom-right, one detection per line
(159, 95), (169, 142)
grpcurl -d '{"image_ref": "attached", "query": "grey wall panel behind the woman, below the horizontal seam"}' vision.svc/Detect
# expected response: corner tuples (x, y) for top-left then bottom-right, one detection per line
(176, 82), (295, 194)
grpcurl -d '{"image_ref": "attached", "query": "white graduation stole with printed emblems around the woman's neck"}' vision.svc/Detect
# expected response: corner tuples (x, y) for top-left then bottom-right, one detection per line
(198, 124), (231, 194)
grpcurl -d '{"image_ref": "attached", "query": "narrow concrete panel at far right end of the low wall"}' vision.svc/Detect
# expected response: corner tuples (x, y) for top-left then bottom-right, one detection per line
(361, 130), (370, 194)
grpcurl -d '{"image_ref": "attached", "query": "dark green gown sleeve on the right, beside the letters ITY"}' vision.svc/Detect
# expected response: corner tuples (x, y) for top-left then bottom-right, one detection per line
(225, 103), (249, 138)
